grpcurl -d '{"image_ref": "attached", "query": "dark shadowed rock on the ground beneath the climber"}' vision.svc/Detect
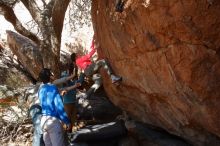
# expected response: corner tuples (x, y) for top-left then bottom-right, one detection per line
(76, 87), (121, 122)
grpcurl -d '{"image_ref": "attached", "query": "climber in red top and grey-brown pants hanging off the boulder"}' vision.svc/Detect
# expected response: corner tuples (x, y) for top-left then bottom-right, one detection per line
(70, 39), (122, 97)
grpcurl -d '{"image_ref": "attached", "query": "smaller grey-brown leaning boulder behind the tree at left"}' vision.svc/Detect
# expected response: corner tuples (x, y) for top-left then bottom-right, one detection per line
(7, 31), (43, 79)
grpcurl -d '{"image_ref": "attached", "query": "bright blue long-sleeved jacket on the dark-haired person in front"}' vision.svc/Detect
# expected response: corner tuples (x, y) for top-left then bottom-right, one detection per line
(38, 83), (70, 125)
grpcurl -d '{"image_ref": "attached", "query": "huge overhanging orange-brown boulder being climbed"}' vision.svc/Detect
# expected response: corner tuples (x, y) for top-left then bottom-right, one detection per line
(92, 0), (220, 145)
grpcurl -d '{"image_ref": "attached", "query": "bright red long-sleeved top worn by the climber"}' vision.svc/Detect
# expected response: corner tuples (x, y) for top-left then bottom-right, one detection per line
(76, 41), (96, 70)
